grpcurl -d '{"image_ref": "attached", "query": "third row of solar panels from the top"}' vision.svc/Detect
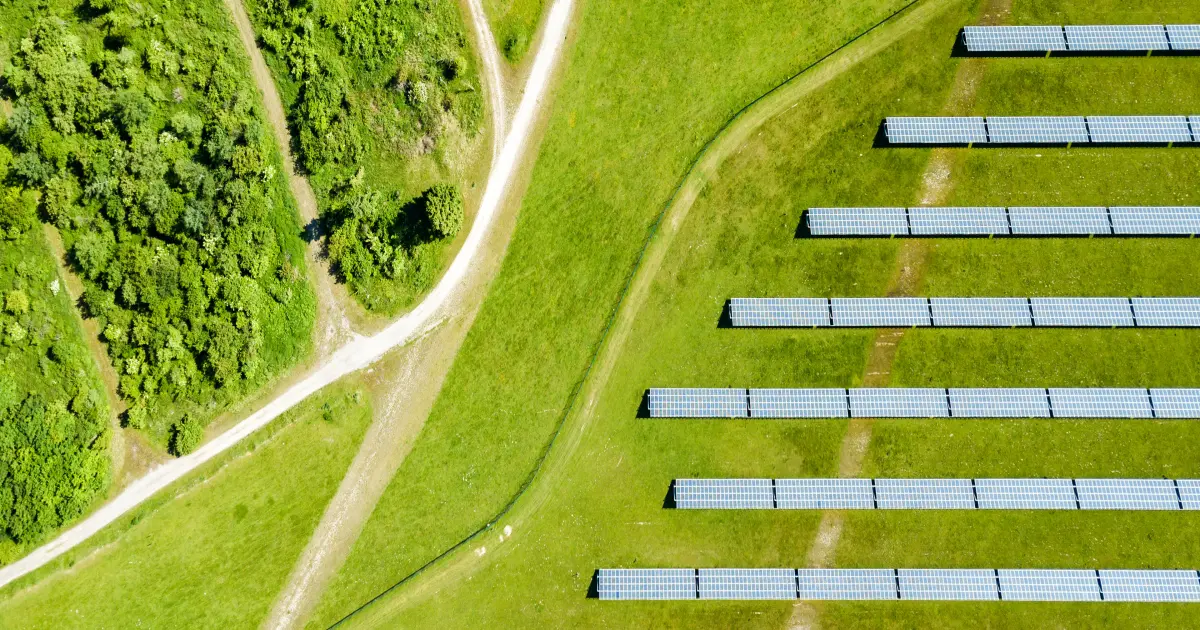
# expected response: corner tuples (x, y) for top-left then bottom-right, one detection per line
(804, 205), (1200, 236)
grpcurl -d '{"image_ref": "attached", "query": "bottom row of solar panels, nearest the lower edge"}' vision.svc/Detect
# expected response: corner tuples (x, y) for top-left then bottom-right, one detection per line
(595, 569), (1200, 601)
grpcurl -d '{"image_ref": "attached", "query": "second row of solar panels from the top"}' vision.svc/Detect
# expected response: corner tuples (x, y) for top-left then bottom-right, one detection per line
(883, 115), (1200, 145)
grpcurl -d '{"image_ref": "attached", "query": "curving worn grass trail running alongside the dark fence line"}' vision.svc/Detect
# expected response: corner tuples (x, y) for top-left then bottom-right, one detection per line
(331, 0), (958, 626)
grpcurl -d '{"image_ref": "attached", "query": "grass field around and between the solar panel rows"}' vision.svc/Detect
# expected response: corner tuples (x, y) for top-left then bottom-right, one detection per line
(333, 0), (1200, 628)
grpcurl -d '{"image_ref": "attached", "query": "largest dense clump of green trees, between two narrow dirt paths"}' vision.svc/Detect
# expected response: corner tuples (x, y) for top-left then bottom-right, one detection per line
(0, 0), (312, 446)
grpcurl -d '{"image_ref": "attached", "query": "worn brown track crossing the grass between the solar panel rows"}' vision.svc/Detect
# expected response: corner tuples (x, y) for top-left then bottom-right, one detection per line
(790, 0), (1013, 628)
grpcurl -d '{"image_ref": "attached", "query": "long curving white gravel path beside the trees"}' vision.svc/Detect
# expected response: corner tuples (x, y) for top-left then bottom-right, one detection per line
(0, 0), (571, 595)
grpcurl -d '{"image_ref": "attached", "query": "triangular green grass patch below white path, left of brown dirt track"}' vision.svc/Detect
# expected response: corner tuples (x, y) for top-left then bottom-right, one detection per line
(0, 380), (371, 628)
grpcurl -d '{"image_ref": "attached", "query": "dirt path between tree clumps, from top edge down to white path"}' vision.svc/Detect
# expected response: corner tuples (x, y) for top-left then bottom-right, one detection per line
(224, 0), (362, 355)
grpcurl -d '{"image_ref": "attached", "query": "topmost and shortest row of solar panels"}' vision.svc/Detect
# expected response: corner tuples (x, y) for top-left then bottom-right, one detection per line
(962, 24), (1200, 53)
